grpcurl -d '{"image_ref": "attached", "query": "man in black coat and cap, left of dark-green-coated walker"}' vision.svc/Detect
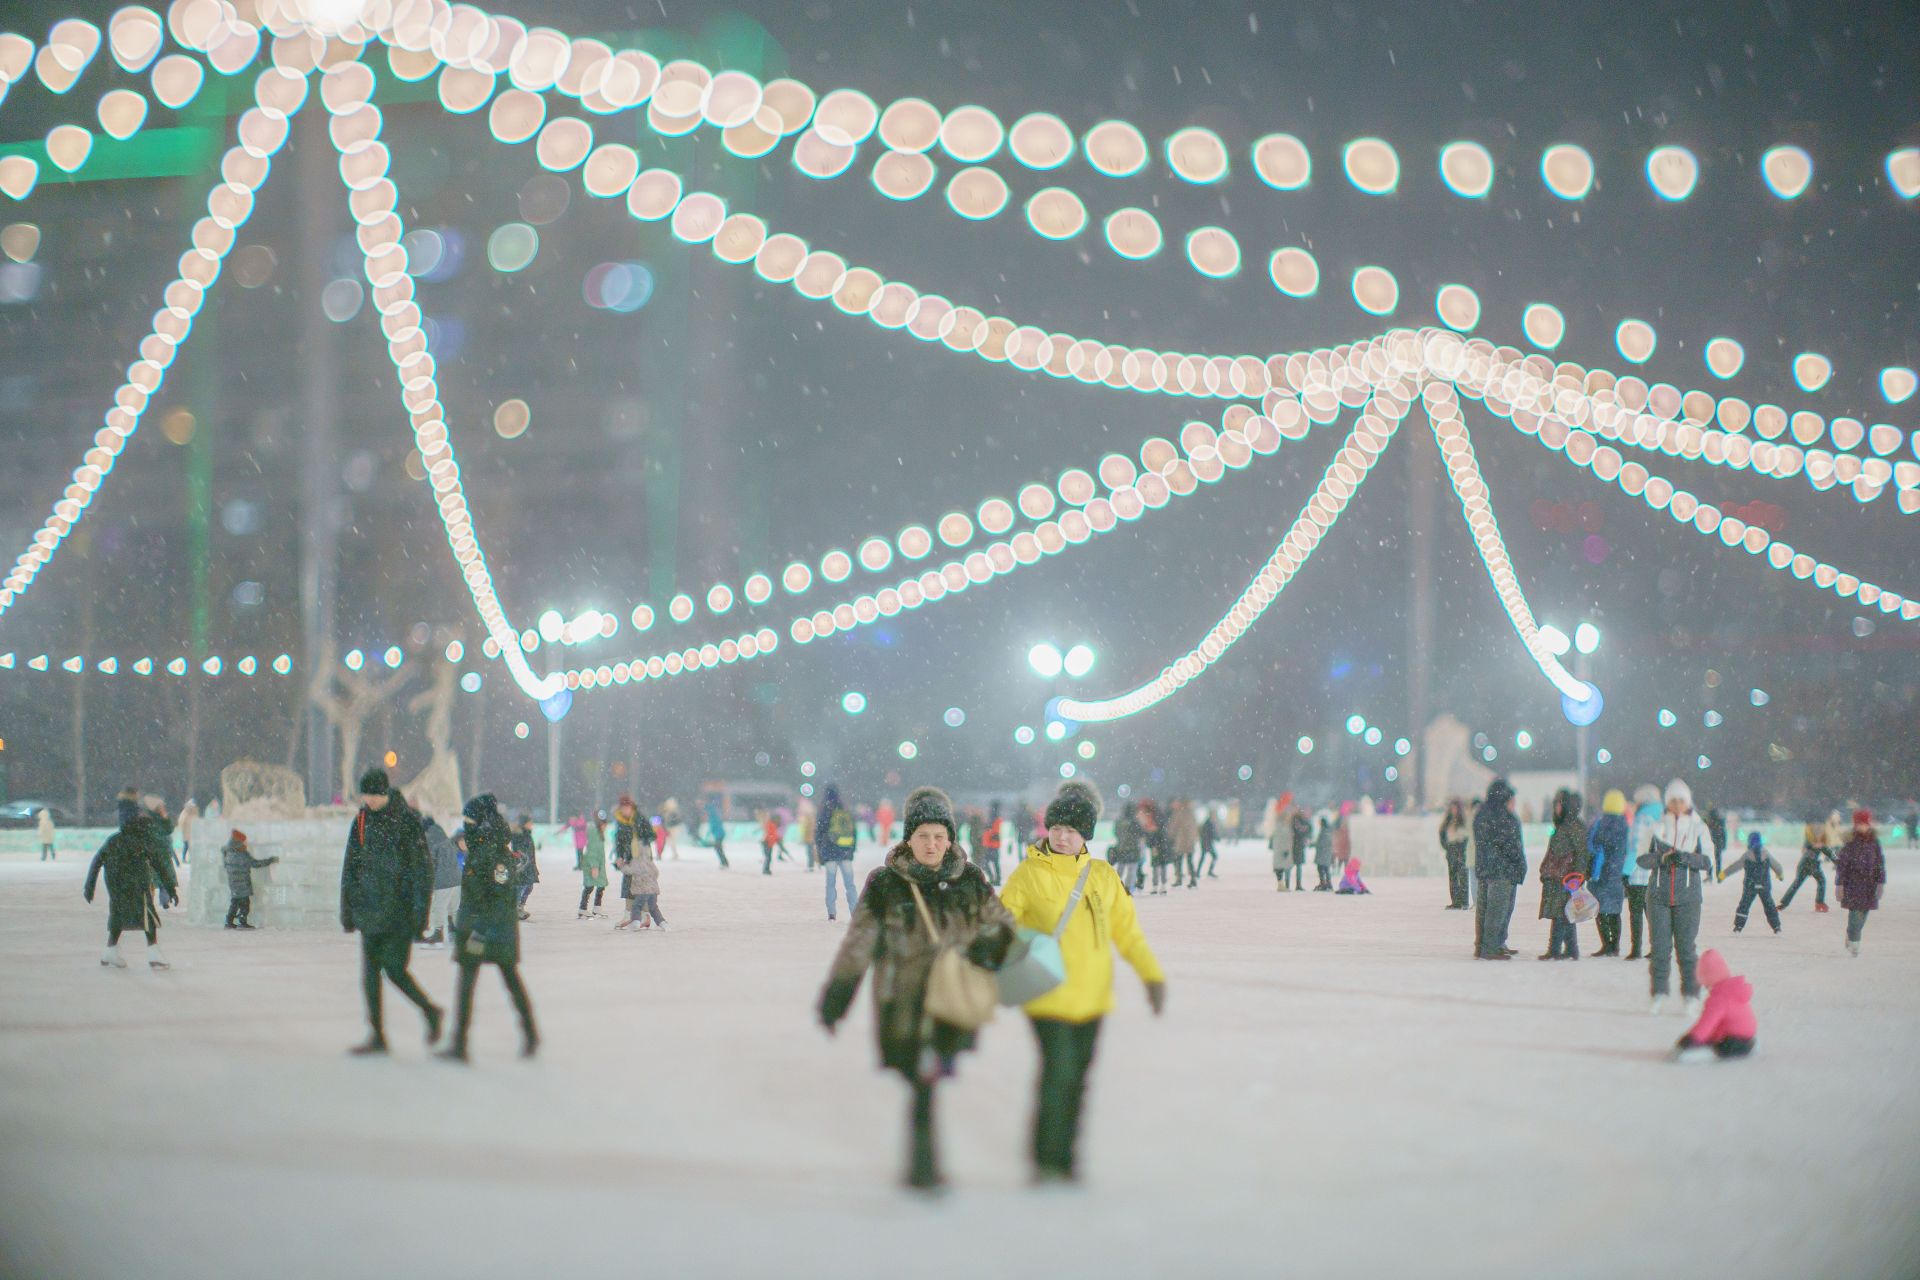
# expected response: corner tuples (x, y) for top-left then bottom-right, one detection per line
(340, 770), (442, 1055)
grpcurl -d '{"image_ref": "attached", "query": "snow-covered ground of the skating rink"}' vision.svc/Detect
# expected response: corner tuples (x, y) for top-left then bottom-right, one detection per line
(0, 844), (1920, 1280)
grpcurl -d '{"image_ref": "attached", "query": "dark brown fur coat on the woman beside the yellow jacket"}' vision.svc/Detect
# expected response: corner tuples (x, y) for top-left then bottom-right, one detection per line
(820, 842), (1014, 1079)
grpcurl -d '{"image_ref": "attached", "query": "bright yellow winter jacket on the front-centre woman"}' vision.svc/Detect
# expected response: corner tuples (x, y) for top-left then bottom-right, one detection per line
(1000, 842), (1165, 1023)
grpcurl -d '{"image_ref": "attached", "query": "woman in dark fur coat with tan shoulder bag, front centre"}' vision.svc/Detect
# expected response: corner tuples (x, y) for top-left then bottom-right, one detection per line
(818, 787), (1023, 1192)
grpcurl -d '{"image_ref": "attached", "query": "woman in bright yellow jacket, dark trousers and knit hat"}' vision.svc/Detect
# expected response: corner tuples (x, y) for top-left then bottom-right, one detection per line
(1000, 781), (1167, 1182)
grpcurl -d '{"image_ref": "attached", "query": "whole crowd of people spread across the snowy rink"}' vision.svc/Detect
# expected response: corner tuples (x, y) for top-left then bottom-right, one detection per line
(67, 768), (1885, 1188)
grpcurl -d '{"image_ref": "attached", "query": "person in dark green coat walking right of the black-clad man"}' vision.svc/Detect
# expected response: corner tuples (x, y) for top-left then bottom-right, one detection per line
(438, 794), (540, 1063)
